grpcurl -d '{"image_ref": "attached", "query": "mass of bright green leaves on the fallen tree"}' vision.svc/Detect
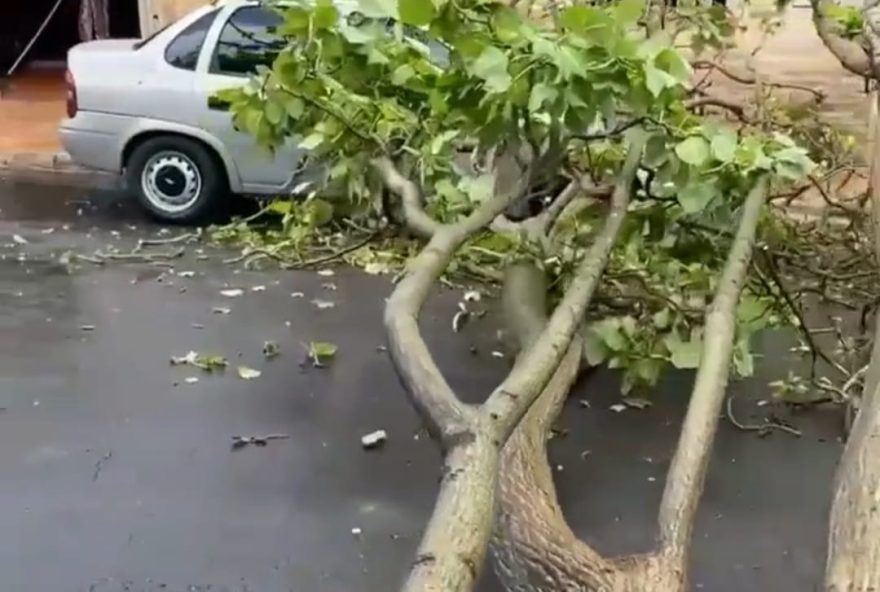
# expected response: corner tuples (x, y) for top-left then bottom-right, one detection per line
(213, 0), (813, 398)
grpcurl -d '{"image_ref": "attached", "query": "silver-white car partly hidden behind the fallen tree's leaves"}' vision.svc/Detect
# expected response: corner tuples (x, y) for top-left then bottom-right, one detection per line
(59, 0), (330, 222)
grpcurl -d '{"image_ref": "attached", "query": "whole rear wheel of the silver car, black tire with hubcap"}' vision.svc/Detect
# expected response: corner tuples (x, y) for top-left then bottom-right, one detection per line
(125, 136), (229, 224)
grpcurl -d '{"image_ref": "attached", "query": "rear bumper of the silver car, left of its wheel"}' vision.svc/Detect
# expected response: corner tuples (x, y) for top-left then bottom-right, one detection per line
(58, 111), (130, 174)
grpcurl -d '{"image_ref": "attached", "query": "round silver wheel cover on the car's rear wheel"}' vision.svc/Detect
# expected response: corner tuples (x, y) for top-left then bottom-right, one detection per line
(141, 151), (202, 214)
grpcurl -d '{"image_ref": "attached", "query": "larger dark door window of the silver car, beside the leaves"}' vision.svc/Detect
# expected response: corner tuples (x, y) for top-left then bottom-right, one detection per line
(211, 6), (285, 76)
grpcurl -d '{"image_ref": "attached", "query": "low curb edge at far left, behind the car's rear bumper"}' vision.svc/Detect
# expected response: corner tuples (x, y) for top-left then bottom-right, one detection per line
(0, 152), (119, 186)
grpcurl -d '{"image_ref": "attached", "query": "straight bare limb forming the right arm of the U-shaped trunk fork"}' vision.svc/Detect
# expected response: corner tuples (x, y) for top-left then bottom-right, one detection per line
(659, 179), (767, 573)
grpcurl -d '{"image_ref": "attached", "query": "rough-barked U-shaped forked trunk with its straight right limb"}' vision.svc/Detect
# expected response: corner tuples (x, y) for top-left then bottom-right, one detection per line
(492, 180), (766, 592)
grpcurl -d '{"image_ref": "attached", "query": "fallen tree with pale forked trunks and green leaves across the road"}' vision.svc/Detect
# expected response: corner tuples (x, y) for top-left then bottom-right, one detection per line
(223, 0), (880, 592)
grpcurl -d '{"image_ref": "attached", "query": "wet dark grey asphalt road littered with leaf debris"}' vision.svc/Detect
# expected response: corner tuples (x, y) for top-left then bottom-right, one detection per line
(0, 178), (840, 592)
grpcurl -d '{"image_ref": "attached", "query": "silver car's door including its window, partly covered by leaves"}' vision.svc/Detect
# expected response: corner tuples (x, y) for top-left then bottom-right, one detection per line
(195, 4), (305, 193)
